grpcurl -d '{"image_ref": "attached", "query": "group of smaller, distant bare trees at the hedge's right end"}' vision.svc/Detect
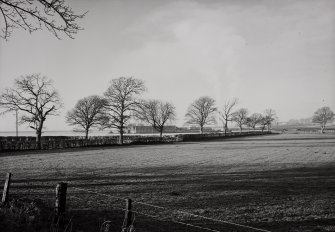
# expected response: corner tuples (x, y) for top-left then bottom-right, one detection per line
(185, 96), (277, 134)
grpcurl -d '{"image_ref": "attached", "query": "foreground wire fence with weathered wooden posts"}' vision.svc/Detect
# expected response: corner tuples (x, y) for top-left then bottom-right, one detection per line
(2, 175), (271, 232)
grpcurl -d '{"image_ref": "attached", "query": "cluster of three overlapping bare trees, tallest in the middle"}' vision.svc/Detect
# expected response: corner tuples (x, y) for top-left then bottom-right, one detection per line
(66, 77), (176, 144)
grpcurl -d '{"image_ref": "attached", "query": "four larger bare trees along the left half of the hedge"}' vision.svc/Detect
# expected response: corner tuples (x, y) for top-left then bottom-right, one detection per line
(0, 74), (176, 149)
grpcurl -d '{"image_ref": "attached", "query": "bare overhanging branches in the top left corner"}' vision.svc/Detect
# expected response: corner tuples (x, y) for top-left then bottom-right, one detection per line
(0, 0), (86, 40)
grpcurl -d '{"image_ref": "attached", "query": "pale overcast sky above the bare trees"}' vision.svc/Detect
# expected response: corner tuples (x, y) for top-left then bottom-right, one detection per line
(0, 0), (335, 131)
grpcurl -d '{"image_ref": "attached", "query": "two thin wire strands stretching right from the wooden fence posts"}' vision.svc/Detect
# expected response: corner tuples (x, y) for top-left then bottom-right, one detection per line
(72, 187), (271, 232)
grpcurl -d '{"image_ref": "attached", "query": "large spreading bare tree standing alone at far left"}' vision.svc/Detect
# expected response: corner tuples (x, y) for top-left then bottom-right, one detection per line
(0, 74), (62, 149)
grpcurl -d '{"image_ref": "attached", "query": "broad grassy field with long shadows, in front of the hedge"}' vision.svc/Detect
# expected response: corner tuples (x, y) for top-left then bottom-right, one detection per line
(0, 134), (335, 231)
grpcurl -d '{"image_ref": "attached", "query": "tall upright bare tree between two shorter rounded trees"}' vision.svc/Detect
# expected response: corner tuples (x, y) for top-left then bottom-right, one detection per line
(104, 77), (146, 144)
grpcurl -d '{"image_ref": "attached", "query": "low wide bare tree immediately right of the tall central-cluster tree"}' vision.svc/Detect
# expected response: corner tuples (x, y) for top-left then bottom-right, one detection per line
(136, 100), (176, 138)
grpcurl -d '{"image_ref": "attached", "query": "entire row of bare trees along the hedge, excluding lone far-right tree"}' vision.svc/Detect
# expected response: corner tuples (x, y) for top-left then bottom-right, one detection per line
(0, 74), (275, 148)
